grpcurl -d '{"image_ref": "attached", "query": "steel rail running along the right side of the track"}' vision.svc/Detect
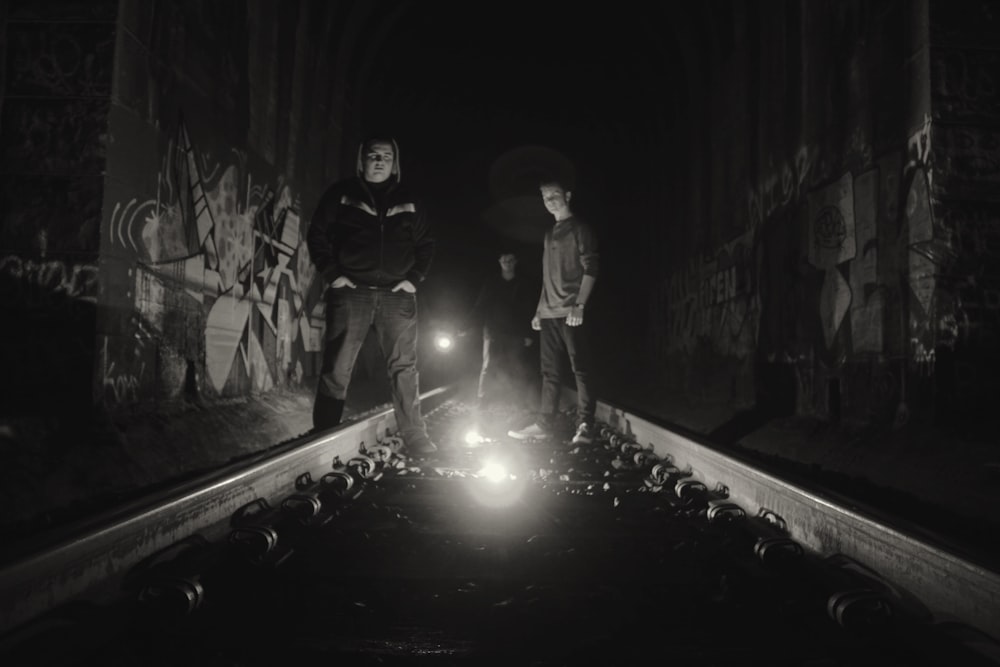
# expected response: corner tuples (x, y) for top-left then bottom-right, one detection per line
(597, 402), (1000, 641)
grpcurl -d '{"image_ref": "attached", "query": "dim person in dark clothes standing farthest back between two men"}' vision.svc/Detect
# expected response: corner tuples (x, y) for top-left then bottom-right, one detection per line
(471, 252), (534, 408)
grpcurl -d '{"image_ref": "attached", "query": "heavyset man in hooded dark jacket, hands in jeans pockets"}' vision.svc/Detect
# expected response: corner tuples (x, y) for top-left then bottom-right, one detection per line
(306, 137), (437, 454)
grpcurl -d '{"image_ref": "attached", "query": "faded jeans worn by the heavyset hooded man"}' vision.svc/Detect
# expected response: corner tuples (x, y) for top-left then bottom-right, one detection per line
(313, 286), (427, 443)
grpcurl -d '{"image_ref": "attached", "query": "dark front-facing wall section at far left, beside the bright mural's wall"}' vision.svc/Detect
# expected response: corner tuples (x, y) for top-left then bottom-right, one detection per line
(0, 0), (117, 415)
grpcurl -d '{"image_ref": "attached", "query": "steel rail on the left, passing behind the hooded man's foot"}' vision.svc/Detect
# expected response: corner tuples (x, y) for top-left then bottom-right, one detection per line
(0, 387), (453, 636)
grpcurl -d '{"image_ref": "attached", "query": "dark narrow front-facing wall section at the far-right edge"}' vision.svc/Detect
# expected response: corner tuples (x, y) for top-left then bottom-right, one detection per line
(924, 0), (1000, 423)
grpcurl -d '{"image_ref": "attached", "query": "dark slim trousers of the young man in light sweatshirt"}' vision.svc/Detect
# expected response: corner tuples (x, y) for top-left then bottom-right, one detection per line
(539, 317), (597, 426)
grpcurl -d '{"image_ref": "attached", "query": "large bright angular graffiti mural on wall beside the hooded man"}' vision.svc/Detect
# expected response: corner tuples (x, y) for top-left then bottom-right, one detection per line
(106, 122), (319, 402)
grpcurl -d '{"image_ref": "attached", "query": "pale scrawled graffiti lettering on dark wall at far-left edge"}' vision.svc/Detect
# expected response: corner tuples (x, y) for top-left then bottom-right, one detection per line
(0, 255), (97, 306)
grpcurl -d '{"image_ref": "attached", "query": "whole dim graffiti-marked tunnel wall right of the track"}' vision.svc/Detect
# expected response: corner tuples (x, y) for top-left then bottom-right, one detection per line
(648, 1), (997, 434)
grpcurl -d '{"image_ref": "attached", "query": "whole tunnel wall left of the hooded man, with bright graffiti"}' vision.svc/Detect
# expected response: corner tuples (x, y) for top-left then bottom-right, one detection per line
(0, 0), (369, 414)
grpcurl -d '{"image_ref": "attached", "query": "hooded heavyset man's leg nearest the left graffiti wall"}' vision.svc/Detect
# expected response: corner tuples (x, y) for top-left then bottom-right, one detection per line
(313, 288), (372, 430)
